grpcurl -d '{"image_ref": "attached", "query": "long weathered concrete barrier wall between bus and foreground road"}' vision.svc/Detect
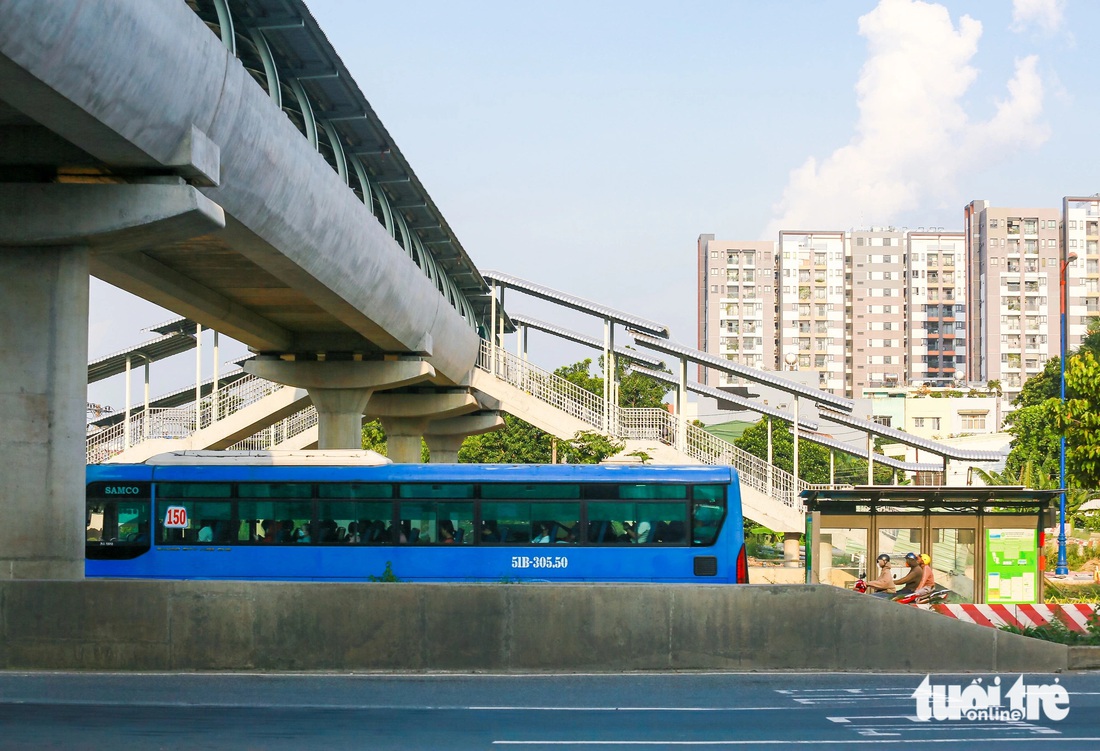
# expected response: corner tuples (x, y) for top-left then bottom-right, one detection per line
(0, 581), (1068, 673)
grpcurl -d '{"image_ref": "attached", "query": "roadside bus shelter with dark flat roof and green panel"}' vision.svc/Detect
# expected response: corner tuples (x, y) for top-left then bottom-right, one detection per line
(802, 485), (1060, 604)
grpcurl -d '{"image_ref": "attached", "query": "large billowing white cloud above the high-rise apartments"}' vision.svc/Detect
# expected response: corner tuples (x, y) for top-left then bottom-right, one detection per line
(765, 0), (1049, 239)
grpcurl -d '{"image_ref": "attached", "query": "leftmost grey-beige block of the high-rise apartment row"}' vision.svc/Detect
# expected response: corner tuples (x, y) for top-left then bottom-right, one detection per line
(699, 234), (776, 386)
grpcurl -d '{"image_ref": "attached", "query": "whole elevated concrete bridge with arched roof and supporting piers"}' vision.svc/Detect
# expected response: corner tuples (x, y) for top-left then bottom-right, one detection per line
(0, 0), (499, 579)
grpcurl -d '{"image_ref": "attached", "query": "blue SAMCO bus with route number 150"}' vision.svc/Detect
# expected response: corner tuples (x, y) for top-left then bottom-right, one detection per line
(86, 451), (748, 583)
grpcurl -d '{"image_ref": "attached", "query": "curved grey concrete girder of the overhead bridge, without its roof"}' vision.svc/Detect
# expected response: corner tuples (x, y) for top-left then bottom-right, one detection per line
(0, 0), (477, 383)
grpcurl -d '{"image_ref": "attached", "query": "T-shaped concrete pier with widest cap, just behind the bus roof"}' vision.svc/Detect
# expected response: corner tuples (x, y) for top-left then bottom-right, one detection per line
(244, 356), (436, 449)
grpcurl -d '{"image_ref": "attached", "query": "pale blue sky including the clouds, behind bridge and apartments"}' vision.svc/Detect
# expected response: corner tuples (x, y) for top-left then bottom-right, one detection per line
(89, 0), (1100, 407)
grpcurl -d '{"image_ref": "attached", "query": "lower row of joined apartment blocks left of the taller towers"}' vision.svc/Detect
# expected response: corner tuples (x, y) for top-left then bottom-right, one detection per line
(699, 229), (966, 397)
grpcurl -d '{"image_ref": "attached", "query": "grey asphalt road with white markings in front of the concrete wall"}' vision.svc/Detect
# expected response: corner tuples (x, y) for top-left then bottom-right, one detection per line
(0, 672), (1100, 751)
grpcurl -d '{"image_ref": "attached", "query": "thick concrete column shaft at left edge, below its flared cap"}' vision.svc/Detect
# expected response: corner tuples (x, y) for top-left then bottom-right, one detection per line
(0, 246), (88, 579)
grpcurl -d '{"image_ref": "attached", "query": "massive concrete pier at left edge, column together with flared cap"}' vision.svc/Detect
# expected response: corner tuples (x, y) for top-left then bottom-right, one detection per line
(0, 178), (226, 579)
